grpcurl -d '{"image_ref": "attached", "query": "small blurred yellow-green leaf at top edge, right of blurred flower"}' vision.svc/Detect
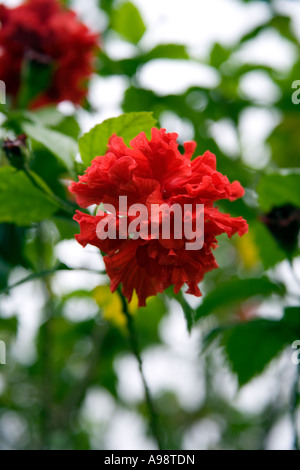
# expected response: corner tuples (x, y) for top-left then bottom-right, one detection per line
(111, 2), (146, 44)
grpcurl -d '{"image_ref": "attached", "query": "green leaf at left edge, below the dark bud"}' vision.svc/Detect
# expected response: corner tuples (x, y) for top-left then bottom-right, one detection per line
(0, 166), (58, 226)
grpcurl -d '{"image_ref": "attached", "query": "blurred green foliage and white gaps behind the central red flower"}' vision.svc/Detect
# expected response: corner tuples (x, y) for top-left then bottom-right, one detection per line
(0, 0), (300, 449)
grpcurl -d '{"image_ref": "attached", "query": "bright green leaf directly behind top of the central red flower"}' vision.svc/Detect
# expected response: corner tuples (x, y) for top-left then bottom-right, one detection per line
(79, 113), (156, 166)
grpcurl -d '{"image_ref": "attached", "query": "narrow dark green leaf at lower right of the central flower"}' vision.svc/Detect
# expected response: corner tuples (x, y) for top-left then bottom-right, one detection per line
(196, 277), (284, 320)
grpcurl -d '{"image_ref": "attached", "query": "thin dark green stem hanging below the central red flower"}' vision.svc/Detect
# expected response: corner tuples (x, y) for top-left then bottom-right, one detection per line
(117, 288), (163, 450)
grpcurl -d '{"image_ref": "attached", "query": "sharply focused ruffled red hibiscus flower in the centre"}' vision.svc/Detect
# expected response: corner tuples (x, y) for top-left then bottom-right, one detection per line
(70, 128), (248, 306)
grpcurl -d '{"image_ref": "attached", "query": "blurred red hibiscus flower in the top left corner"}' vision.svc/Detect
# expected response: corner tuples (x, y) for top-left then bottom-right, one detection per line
(0, 0), (97, 108)
